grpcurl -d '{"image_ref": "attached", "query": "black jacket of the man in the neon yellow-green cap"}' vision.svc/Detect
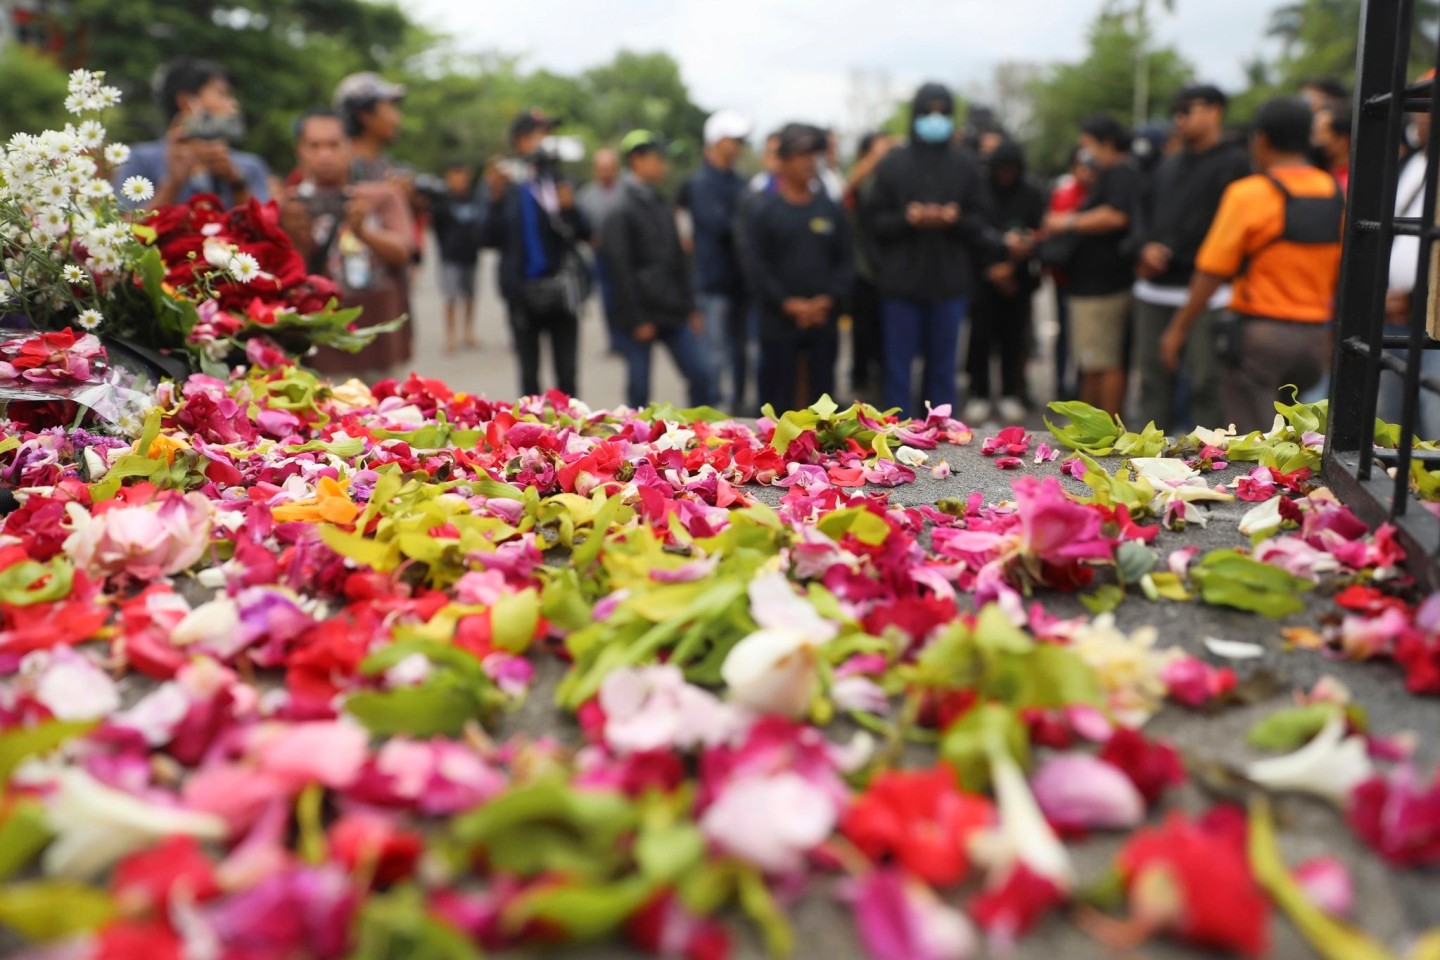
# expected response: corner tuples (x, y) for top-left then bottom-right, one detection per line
(600, 178), (696, 330)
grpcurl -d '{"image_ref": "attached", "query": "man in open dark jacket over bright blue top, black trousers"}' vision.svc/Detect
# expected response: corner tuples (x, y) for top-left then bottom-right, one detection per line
(481, 109), (590, 397)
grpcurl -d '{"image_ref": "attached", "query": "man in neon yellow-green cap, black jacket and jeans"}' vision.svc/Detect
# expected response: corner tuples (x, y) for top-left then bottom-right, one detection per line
(600, 130), (713, 410)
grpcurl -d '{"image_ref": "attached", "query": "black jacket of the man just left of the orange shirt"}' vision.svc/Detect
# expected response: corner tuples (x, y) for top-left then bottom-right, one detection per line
(1136, 142), (1250, 286)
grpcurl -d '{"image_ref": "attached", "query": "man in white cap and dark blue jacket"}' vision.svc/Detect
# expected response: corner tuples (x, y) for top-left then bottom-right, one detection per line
(683, 109), (752, 413)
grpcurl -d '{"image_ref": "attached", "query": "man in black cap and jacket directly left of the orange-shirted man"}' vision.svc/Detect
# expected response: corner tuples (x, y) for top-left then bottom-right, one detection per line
(1135, 85), (1250, 430)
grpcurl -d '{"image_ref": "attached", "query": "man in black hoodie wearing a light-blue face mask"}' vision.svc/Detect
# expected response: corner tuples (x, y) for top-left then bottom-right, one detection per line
(867, 83), (1002, 416)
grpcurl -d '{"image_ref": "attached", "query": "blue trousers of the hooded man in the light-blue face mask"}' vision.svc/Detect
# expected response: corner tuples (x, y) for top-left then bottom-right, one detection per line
(880, 298), (969, 416)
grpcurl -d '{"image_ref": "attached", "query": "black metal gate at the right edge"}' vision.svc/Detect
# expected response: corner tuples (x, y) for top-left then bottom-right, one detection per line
(1325, 0), (1440, 590)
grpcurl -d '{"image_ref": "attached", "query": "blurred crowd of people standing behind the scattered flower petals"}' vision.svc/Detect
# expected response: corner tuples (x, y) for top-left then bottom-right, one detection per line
(118, 60), (1440, 429)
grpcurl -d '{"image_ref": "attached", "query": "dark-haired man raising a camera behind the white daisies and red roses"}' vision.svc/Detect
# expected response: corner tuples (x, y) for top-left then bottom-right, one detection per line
(115, 58), (271, 209)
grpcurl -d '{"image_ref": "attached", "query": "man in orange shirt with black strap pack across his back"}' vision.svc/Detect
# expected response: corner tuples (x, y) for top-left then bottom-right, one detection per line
(1161, 98), (1345, 433)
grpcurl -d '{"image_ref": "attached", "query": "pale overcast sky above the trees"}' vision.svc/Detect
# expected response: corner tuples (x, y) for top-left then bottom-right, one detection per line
(402, 0), (1277, 136)
